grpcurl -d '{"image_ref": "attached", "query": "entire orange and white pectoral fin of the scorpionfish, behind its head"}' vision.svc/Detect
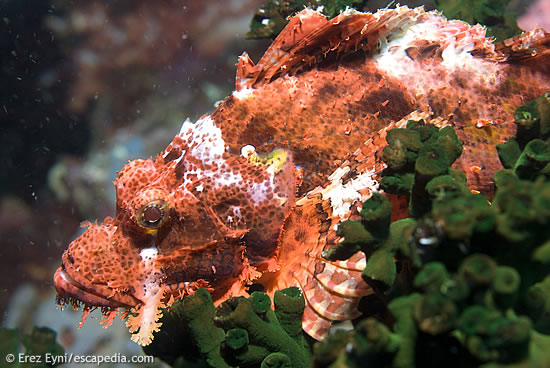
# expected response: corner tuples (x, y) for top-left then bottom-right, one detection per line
(270, 112), (438, 340)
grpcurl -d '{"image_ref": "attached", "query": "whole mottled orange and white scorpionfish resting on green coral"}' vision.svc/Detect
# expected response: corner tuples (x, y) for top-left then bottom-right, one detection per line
(54, 6), (550, 345)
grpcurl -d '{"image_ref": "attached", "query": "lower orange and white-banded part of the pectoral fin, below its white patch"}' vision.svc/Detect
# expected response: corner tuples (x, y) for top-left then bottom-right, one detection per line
(270, 195), (372, 340)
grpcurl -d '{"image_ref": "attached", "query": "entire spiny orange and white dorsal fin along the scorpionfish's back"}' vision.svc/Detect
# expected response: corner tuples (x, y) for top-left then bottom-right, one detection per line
(236, 6), (532, 91)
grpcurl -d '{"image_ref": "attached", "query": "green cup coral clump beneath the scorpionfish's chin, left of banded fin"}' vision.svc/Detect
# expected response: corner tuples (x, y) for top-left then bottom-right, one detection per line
(144, 287), (311, 368)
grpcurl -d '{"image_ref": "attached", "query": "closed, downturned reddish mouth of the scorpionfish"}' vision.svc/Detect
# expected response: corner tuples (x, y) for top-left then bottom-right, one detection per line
(53, 265), (140, 309)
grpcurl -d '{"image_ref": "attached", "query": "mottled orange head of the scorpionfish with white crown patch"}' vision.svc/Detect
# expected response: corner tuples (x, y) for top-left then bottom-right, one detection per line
(54, 117), (297, 316)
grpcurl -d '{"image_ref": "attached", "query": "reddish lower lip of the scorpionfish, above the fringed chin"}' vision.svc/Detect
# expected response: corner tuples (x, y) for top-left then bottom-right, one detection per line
(53, 266), (136, 308)
